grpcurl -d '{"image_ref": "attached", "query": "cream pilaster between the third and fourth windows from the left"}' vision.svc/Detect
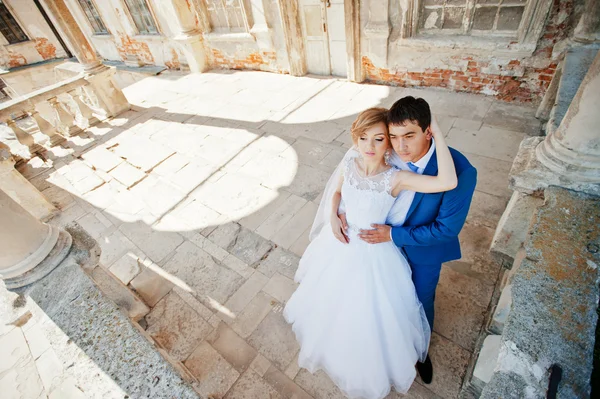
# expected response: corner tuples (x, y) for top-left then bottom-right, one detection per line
(171, 0), (208, 72)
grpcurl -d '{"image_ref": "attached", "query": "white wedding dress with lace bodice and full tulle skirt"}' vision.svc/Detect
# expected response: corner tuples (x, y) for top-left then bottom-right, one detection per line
(284, 158), (430, 399)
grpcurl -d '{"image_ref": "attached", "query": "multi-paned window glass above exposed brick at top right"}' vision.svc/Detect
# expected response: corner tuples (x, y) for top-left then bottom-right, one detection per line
(419, 0), (527, 37)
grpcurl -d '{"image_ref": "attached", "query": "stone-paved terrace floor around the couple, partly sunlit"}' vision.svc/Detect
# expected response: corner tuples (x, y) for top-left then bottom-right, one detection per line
(8, 72), (540, 399)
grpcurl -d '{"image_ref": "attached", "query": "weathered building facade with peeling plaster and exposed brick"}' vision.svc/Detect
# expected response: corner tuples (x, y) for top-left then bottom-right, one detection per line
(4, 0), (597, 101)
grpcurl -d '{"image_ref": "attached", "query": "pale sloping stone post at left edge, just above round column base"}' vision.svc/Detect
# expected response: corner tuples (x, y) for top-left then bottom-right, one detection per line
(0, 147), (58, 222)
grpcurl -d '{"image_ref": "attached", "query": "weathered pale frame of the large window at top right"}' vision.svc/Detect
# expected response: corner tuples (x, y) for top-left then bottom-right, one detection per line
(401, 0), (552, 45)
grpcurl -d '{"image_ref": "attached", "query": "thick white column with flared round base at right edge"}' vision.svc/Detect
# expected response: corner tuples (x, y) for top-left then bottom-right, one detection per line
(536, 52), (600, 183)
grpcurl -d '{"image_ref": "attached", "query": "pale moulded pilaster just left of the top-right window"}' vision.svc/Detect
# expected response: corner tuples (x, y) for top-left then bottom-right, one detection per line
(363, 0), (392, 67)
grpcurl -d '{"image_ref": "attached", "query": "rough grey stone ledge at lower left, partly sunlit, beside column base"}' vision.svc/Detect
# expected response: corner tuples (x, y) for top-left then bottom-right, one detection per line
(14, 239), (198, 399)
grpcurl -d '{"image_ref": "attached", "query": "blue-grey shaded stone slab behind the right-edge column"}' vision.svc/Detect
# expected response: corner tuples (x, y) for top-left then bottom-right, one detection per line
(546, 44), (599, 135)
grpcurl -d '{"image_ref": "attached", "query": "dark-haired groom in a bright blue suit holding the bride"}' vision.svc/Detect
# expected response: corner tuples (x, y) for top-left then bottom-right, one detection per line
(359, 96), (477, 384)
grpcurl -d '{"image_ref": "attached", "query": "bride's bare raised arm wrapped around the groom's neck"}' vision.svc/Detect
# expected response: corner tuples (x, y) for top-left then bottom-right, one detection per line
(392, 117), (458, 196)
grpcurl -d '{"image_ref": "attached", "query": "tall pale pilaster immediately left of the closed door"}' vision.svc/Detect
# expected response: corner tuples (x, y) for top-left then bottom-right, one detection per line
(277, 0), (306, 76)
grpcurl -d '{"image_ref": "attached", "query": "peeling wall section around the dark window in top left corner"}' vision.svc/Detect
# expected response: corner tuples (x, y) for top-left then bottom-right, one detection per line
(0, 0), (67, 69)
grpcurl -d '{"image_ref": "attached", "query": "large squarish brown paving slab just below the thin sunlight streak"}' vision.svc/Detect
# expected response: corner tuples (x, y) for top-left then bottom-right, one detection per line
(146, 292), (212, 361)
